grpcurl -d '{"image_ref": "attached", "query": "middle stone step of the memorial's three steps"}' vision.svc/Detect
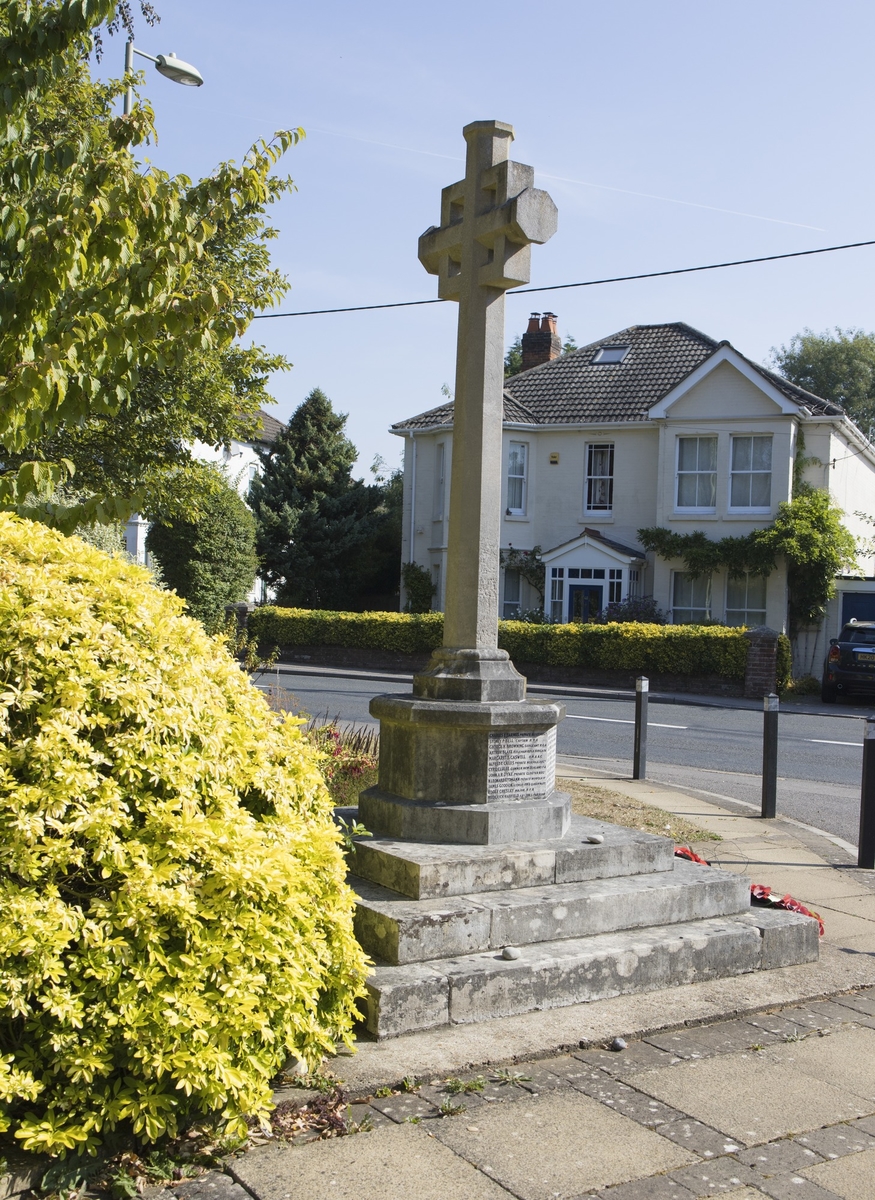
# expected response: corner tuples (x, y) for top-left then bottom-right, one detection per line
(349, 859), (750, 965)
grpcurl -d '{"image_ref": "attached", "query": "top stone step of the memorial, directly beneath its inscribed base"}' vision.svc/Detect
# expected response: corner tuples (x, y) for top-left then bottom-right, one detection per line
(347, 811), (675, 900)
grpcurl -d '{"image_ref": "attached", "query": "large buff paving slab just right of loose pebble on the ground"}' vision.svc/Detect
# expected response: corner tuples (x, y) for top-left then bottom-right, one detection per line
(635, 1039), (874, 1145)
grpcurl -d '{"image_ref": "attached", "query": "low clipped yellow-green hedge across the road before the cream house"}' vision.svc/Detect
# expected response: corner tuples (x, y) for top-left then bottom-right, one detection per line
(250, 607), (790, 686)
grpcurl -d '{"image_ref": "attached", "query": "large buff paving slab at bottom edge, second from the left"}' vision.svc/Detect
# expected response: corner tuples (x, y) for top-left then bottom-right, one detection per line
(429, 1092), (695, 1200)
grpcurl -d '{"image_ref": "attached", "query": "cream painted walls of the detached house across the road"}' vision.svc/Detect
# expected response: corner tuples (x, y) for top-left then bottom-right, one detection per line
(393, 362), (875, 629)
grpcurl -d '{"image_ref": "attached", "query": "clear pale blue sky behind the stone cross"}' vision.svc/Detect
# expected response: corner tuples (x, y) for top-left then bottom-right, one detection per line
(102, 0), (875, 473)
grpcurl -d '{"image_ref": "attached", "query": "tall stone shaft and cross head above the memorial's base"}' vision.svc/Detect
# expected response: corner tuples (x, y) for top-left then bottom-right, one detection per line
(419, 121), (557, 649)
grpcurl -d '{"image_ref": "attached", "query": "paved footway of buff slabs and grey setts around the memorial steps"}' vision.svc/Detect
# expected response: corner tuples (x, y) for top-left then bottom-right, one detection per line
(6, 760), (875, 1200)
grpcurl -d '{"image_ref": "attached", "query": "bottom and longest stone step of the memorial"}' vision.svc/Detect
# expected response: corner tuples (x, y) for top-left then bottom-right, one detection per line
(362, 908), (819, 1038)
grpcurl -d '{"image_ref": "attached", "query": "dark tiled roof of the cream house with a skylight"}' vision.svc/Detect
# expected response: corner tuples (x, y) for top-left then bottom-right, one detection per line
(392, 322), (844, 433)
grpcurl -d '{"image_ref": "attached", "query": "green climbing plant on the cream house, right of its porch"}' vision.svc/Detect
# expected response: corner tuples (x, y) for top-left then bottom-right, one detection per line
(639, 485), (856, 632)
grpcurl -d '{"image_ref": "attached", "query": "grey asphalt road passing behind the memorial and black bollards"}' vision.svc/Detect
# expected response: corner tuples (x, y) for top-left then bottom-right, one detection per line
(261, 667), (874, 845)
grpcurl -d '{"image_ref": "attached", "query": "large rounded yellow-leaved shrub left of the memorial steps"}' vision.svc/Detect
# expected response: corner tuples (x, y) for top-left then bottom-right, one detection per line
(0, 515), (366, 1152)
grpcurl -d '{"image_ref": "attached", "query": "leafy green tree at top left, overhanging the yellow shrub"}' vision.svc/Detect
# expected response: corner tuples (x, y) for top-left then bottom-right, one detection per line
(0, 0), (302, 528)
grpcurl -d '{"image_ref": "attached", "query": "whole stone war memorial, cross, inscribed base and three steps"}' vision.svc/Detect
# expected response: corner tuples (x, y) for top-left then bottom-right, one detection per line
(350, 121), (817, 1038)
